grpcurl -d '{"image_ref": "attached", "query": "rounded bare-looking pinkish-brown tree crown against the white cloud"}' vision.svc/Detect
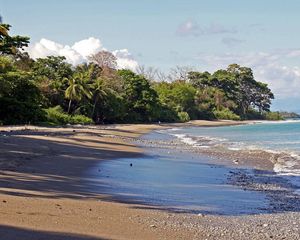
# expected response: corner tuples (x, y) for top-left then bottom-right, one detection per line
(89, 50), (117, 69)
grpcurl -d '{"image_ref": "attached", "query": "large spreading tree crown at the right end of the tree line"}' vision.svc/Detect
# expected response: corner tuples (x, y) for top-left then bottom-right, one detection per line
(189, 64), (274, 119)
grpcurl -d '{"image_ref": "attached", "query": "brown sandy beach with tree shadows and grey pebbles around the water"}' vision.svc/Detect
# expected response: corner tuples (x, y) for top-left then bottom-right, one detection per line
(0, 121), (300, 239)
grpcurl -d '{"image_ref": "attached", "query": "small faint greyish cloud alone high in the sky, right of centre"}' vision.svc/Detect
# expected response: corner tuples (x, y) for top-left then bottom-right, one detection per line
(176, 20), (238, 37)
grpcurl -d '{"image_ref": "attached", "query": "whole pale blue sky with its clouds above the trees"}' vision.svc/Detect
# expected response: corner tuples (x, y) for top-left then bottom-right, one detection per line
(0, 0), (300, 112)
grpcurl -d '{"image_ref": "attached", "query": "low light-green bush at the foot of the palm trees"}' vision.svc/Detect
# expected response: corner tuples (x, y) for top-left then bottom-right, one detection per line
(45, 106), (93, 125)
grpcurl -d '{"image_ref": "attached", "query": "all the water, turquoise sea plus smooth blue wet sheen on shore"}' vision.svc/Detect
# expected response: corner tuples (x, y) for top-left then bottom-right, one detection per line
(86, 121), (300, 215)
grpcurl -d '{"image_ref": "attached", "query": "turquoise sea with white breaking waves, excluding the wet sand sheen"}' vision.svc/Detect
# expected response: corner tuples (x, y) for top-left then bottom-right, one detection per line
(167, 121), (300, 186)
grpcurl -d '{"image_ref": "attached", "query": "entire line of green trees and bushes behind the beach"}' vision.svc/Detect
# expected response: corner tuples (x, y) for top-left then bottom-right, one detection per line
(0, 24), (280, 124)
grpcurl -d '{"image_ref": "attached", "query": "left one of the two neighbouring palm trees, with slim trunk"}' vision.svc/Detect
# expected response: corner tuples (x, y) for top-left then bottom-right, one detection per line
(65, 72), (92, 113)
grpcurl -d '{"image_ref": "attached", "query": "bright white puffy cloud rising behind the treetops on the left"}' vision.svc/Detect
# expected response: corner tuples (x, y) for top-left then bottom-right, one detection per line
(27, 37), (138, 70)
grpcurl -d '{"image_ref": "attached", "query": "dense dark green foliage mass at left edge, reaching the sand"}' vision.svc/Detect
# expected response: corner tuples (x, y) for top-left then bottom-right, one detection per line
(0, 57), (44, 124)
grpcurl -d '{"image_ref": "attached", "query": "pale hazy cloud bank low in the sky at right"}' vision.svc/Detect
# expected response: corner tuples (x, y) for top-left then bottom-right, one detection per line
(197, 49), (300, 99)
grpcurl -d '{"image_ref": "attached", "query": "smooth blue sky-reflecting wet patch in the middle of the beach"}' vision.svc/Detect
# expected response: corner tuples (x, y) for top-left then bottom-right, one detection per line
(85, 149), (269, 215)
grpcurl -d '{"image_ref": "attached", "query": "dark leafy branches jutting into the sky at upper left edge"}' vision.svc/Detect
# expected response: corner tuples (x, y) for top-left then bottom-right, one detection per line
(0, 23), (29, 55)
